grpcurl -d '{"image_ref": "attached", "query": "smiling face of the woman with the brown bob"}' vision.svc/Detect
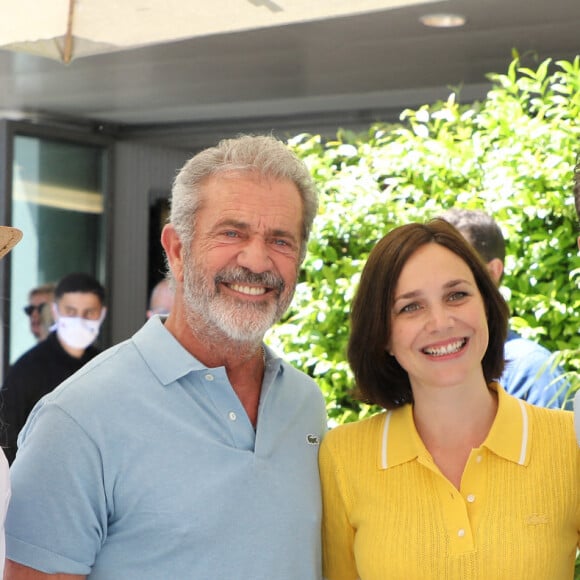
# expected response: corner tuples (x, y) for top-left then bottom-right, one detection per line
(387, 243), (489, 402)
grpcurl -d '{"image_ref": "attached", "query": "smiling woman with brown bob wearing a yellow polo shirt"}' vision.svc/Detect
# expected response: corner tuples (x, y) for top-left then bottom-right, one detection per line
(319, 220), (580, 580)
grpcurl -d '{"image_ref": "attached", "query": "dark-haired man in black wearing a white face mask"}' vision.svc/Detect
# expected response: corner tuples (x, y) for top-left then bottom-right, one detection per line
(0, 272), (107, 464)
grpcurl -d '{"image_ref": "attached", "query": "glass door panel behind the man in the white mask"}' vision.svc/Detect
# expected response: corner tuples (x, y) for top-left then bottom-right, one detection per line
(4, 125), (108, 364)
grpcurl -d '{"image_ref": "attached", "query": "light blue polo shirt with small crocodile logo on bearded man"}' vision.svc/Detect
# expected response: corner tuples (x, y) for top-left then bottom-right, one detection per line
(6, 317), (326, 580)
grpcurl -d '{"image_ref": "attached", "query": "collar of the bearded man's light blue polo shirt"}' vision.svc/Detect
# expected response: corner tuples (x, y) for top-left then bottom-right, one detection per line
(133, 315), (284, 386)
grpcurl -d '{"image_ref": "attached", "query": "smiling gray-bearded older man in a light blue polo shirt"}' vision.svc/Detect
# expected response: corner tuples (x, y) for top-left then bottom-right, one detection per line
(6, 137), (326, 580)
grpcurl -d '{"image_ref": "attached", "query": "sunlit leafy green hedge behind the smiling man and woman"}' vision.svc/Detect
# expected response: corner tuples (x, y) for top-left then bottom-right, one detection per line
(268, 58), (580, 423)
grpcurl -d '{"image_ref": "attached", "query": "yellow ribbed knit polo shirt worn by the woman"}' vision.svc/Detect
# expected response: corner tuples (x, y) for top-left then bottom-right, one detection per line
(320, 389), (580, 580)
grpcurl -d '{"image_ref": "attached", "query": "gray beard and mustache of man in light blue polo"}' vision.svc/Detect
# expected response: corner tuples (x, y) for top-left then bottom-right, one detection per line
(183, 256), (294, 343)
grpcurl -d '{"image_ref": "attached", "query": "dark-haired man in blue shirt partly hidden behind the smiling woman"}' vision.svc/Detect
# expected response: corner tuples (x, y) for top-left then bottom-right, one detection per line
(440, 209), (568, 408)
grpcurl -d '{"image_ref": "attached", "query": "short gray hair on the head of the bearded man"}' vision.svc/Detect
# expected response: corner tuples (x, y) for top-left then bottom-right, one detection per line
(169, 135), (318, 260)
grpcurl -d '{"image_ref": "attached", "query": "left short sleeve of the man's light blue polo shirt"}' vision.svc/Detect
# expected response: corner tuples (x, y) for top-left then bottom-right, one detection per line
(6, 403), (107, 575)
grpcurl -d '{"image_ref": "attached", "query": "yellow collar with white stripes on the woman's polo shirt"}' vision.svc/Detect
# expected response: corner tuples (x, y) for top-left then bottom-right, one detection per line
(378, 383), (531, 469)
